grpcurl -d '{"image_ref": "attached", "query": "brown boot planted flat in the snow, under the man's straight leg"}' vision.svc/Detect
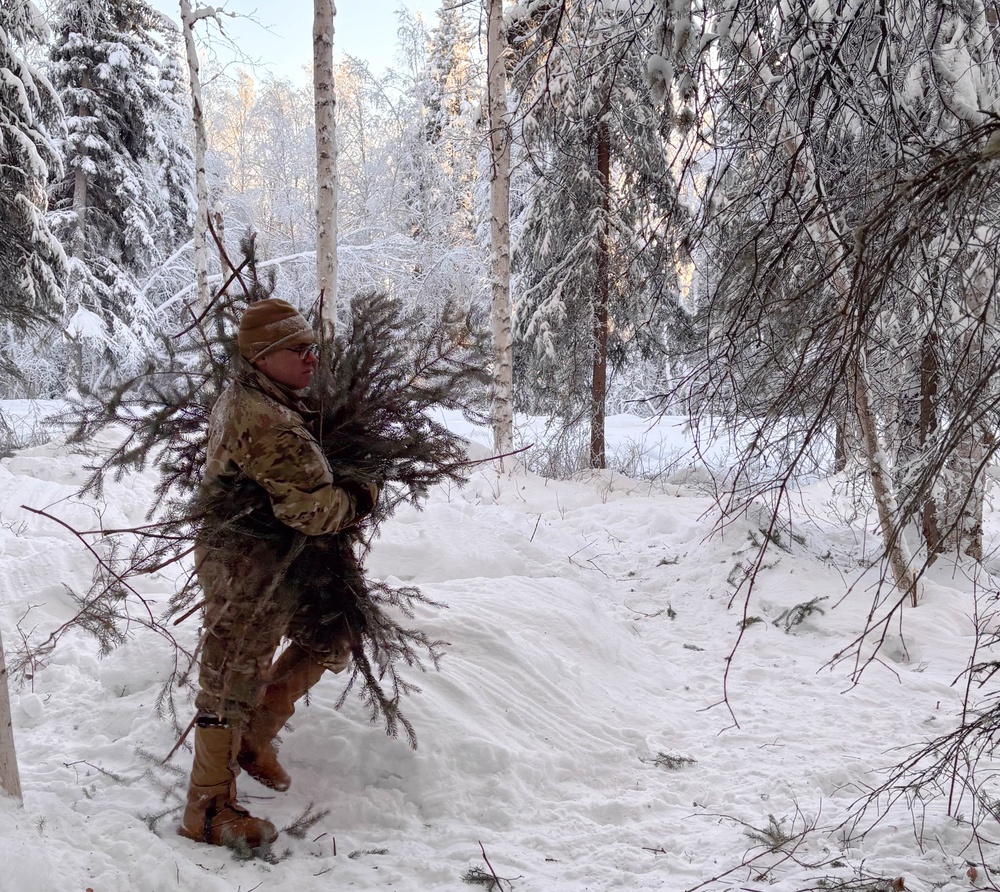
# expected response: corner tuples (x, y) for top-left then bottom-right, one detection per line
(177, 728), (278, 848)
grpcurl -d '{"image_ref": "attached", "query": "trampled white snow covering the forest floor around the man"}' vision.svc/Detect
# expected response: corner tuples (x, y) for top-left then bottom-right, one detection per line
(0, 407), (1000, 892)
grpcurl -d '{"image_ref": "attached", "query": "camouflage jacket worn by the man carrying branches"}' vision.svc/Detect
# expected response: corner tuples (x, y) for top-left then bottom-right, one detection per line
(202, 358), (356, 536)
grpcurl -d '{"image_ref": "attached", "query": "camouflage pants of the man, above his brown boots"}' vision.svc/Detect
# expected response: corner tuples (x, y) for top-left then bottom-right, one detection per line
(195, 547), (352, 727)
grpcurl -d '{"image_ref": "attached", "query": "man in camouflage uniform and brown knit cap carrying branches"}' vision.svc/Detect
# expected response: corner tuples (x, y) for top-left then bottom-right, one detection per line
(178, 298), (378, 847)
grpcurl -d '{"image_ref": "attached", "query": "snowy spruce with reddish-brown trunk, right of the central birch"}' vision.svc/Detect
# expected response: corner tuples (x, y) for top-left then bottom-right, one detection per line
(508, 2), (679, 467)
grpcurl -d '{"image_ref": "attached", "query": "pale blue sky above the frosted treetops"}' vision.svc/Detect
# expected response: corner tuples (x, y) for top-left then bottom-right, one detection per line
(150, 0), (438, 81)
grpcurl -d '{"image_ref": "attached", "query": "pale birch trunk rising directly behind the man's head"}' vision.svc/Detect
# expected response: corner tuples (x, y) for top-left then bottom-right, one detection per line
(313, 0), (337, 340)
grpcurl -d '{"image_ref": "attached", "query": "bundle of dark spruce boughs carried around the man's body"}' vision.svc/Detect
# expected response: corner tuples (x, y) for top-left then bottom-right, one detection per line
(60, 242), (488, 745)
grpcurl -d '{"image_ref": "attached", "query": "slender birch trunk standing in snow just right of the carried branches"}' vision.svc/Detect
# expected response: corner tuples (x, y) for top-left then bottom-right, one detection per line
(486, 0), (514, 454)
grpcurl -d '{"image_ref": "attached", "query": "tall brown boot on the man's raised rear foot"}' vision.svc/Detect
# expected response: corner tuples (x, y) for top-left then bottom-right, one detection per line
(237, 644), (326, 791)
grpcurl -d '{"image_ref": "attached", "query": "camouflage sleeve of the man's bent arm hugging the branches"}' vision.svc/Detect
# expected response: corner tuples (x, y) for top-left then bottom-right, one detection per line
(242, 426), (355, 536)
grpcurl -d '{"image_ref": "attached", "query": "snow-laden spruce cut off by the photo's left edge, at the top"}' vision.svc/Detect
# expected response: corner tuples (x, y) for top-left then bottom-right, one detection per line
(0, 0), (66, 374)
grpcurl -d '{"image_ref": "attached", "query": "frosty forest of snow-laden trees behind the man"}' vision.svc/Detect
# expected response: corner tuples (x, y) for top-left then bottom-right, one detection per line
(7, 0), (1000, 884)
